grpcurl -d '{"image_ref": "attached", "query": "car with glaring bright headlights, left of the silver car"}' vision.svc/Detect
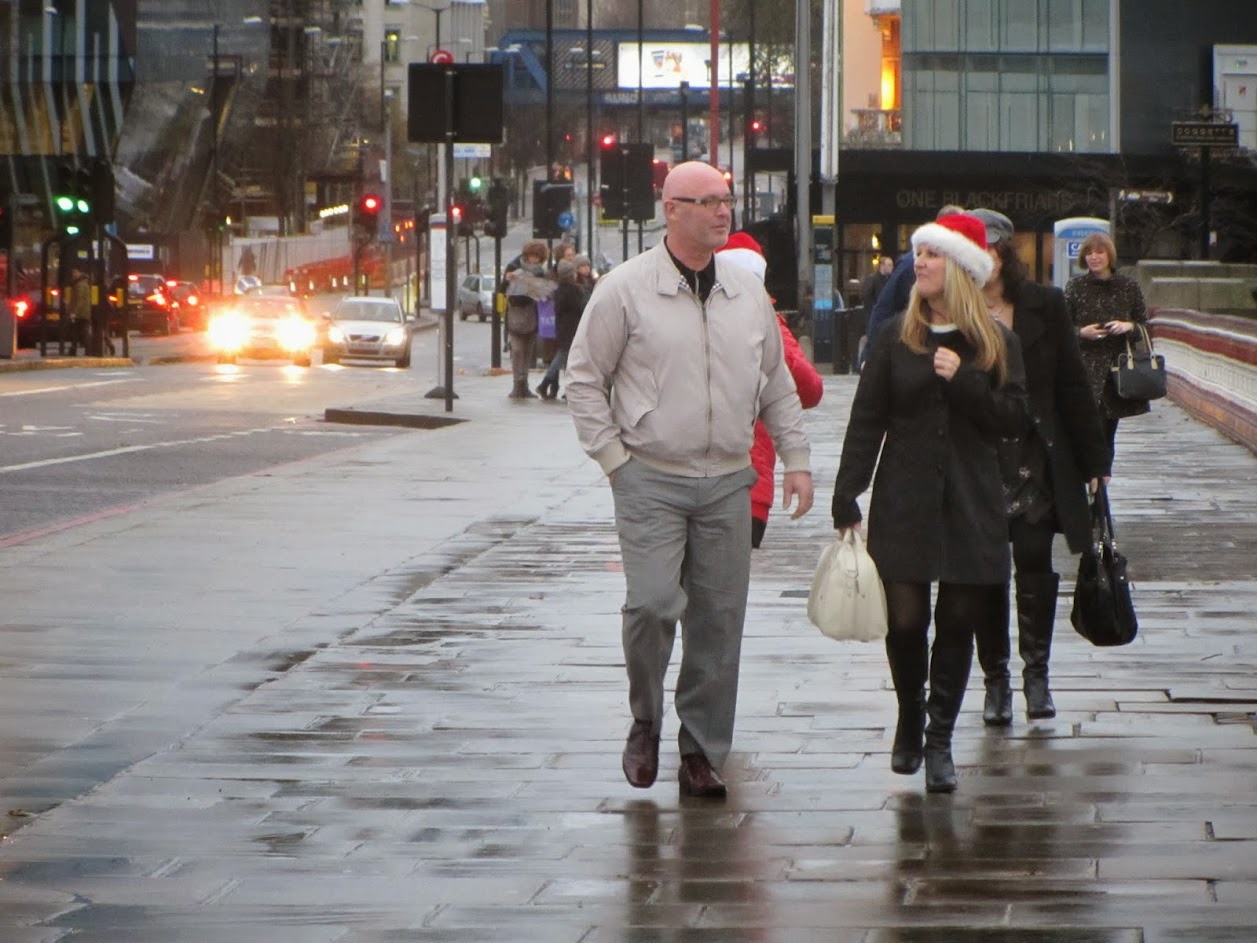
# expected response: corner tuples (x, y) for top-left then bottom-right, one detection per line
(206, 294), (318, 367)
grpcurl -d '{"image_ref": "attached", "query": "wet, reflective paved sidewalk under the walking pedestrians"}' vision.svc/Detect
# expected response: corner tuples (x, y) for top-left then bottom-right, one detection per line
(0, 364), (1257, 943)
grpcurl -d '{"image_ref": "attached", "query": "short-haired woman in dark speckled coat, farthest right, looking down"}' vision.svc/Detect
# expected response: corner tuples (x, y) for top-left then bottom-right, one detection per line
(1065, 233), (1151, 451)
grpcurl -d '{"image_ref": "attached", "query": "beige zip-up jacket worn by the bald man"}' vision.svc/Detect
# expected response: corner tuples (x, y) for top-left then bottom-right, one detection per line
(566, 241), (810, 478)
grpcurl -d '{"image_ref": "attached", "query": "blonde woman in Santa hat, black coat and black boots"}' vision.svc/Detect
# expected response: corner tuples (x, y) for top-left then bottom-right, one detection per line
(833, 214), (1026, 792)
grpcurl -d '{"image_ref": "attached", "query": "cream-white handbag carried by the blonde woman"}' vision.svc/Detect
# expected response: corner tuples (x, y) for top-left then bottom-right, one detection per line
(807, 527), (886, 641)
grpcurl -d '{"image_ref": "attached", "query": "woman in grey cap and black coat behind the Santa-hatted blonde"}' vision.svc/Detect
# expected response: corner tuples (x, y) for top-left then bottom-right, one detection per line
(973, 209), (1111, 727)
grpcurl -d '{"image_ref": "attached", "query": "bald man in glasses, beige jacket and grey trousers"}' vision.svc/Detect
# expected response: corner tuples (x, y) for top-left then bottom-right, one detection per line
(567, 162), (812, 798)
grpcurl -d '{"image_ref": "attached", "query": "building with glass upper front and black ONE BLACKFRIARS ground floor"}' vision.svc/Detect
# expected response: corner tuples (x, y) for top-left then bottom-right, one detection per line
(835, 0), (1257, 295)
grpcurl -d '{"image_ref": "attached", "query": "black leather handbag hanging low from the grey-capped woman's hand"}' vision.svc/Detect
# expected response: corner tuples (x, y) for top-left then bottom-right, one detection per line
(1070, 484), (1139, 646)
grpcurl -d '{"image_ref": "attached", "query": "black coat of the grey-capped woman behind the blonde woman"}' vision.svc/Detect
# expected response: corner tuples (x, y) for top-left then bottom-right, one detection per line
(1013, 282), (1112, 553)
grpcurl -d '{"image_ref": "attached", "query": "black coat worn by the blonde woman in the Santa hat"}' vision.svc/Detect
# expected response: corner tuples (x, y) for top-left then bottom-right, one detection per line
(833, 318), (1027, 585)
